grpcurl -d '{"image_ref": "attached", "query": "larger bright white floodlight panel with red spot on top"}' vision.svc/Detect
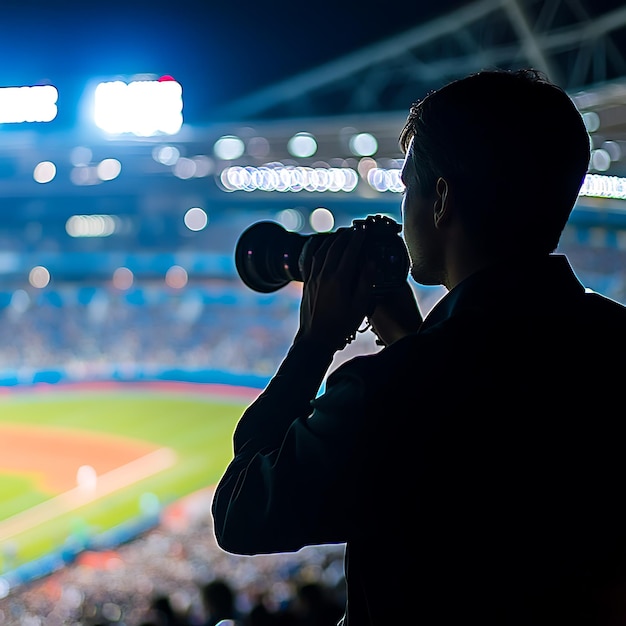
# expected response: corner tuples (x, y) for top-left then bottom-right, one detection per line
(94, 76), (183, 137)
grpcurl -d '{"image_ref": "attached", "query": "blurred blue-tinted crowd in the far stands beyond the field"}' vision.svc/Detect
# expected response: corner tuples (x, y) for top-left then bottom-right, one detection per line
(0, 282), (299, 380)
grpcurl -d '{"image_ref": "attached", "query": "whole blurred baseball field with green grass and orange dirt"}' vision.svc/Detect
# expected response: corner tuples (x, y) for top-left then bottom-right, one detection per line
(0, 382), (259, 574)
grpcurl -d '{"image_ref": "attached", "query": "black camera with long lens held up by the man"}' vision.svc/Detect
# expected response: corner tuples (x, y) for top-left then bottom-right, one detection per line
(235, 215), (409, 295)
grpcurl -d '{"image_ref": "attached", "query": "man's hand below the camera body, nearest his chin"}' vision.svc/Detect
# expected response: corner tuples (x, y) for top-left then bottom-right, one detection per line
(369, 282), (422, 346)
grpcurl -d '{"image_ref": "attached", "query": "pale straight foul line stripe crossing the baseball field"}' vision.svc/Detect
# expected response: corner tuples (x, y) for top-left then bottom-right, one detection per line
(0, 448), (176, 541)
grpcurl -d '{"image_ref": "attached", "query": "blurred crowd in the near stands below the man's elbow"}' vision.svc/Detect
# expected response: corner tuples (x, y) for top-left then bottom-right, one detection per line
(0, 490), (345, 626)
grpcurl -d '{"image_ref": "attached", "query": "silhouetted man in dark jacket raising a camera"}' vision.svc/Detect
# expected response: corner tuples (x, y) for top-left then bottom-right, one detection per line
(213, 70), (626, 626)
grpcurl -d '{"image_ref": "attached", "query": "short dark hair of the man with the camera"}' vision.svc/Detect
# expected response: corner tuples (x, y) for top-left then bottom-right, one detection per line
(400, 69), (590, 253)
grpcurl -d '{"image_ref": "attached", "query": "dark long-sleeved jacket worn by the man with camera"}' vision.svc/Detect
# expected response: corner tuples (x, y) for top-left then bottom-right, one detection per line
(213, 255), (626, 626)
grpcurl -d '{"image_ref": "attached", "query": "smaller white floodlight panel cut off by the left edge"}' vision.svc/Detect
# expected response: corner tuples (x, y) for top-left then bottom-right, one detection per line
(0, 85), (59, 124)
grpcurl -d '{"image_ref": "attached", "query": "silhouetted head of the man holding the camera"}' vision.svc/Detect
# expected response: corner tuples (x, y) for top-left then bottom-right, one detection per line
(400, 70), (589, 287)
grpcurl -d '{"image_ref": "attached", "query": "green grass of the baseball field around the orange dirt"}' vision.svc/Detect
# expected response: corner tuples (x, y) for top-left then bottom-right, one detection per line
(0, 385), (251, 573)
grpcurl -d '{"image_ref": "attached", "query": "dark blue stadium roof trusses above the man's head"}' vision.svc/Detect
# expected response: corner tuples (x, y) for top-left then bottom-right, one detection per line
(210, 0), (626, 119)
